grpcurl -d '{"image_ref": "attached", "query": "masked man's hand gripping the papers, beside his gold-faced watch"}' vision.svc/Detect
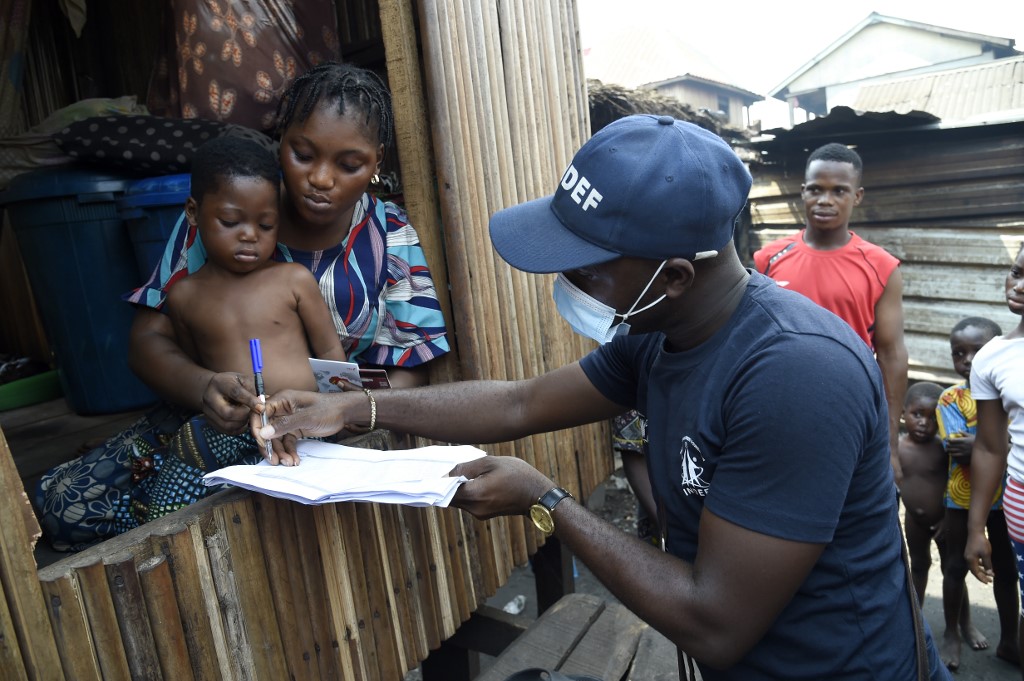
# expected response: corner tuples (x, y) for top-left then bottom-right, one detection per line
(449, 457), (557, 520)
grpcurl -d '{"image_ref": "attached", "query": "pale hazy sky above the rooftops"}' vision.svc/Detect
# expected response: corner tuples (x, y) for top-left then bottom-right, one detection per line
(577, 0), (1024, 124)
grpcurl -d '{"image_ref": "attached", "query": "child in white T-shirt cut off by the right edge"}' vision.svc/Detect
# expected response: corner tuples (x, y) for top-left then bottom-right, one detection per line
(964, 245), (1024, 676)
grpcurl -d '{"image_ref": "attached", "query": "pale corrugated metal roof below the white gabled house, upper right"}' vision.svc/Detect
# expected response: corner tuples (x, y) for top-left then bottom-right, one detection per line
(853, 54), (1024, 123)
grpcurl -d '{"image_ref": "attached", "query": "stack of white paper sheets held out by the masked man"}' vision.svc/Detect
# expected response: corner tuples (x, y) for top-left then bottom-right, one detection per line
(203, 439), (486, 506)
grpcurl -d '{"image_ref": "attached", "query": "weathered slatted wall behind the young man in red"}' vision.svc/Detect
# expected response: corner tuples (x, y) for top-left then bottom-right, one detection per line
(748, 123), (1024, 383)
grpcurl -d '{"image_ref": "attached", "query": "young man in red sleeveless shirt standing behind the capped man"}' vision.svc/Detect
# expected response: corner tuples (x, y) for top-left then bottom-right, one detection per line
(754, 142), (907, 484)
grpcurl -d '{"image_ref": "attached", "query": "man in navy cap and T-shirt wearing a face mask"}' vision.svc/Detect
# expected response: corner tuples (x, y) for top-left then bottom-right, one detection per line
(260, 116), (949, 681)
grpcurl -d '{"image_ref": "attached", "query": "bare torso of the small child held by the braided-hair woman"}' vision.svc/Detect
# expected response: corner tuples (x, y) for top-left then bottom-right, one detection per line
(166, 263), (327, 393)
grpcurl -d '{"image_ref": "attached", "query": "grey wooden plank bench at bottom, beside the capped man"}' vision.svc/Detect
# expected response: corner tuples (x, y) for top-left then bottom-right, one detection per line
(476, 594), (679, 681)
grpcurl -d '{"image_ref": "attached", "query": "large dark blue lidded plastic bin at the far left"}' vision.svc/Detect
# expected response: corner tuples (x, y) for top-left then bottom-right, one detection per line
(0, 169), (157, 414)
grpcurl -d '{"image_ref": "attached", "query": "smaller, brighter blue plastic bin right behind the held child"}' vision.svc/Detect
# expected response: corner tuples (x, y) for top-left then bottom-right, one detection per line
(118, 173), (191, 280)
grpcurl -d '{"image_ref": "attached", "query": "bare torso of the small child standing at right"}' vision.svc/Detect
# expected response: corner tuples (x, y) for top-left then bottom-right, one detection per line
(899, 435), (948, 527)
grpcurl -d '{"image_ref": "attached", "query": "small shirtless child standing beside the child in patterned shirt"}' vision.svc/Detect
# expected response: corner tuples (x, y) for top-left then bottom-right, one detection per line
(899, 382), (946, 602)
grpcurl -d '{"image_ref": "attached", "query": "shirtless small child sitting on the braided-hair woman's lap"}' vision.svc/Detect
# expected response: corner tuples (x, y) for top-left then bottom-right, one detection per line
(167, 137), (345, 458)
